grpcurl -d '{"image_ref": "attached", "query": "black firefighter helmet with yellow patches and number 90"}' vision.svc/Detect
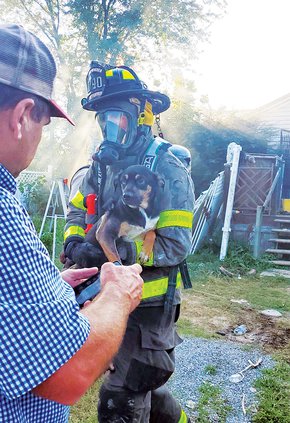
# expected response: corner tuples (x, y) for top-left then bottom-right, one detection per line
(82, 61), (170, 115)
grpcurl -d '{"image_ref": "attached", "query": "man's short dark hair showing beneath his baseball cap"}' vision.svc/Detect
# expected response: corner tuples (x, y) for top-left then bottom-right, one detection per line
(0, 83), (50, 122)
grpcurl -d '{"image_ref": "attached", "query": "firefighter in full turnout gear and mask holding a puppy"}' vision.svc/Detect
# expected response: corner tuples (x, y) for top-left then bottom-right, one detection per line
(64, 61), (194, 423)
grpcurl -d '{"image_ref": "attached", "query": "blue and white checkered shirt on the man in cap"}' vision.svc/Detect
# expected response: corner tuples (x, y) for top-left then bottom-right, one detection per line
(0, 165), (90, 423)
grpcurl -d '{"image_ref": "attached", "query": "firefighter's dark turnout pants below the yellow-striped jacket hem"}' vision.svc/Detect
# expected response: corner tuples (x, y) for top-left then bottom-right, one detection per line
(98, 306), (189, 423)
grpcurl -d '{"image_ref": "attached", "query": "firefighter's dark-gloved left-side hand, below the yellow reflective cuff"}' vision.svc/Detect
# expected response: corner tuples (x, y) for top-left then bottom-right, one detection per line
(65, 241), (107, 267)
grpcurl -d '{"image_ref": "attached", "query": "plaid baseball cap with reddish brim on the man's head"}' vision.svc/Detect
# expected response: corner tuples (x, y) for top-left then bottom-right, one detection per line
(0, 24), (74, 125)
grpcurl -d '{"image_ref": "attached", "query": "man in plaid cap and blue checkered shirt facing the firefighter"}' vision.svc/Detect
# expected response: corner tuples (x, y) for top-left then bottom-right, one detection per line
(0, 25), (143, 423)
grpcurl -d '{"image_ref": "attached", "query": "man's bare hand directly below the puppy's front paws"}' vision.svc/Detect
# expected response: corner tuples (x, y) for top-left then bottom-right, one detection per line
(101, 263), (143, 313)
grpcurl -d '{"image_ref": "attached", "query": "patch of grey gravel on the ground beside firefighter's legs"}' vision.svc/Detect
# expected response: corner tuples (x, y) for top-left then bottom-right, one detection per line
(168, 338), (275, 423)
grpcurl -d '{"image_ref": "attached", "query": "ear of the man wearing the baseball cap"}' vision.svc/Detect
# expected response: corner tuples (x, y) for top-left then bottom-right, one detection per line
(10, 98), (34, 140)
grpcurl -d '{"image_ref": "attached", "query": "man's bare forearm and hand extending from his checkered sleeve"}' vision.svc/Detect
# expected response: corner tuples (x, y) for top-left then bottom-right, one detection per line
(33, 263), (143, 405)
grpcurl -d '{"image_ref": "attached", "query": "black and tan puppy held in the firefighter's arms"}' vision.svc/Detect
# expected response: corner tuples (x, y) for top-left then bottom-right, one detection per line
(86, 165), (164, 263)
